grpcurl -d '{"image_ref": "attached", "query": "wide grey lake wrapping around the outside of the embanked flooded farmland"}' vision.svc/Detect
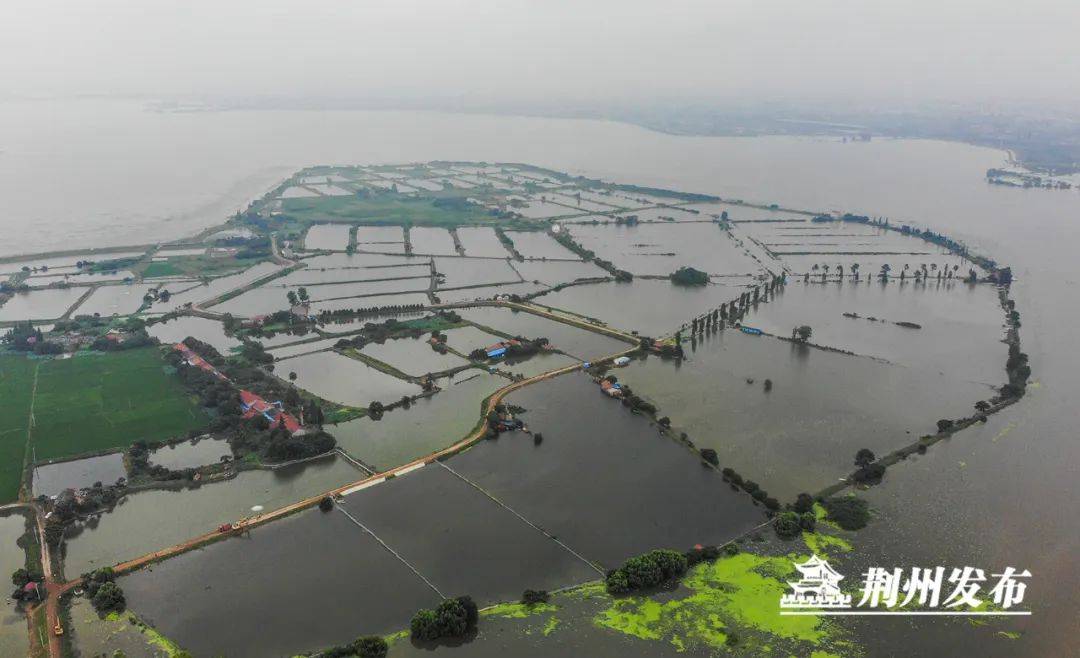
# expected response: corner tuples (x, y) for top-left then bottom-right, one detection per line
(0, 100), (1080, 656)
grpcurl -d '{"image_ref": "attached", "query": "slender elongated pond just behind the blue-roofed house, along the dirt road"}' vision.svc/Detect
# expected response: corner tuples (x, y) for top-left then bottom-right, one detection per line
(458, 307), (632, 361)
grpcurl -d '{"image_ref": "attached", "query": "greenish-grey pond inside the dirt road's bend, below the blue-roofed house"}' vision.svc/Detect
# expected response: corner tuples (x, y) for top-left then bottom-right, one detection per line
(326, 369), (510, 470)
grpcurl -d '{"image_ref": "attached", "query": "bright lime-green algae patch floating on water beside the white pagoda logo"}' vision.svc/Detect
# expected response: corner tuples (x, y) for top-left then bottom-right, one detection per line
(593, 553), (839, 650)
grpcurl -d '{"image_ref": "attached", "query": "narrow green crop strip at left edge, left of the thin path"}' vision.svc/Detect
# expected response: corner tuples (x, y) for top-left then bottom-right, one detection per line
(0, 355), (39, 502)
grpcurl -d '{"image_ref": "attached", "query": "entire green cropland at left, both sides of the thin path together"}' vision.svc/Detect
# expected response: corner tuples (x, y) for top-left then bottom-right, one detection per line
(0, 347), (207, 502)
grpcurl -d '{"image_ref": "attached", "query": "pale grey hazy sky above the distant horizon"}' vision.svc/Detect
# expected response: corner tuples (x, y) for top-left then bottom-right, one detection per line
(8, 0), (1080, 105)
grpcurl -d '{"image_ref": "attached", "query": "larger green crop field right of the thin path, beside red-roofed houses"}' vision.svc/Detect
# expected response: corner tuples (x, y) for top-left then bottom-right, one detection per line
(30, 348), (207, 461)
